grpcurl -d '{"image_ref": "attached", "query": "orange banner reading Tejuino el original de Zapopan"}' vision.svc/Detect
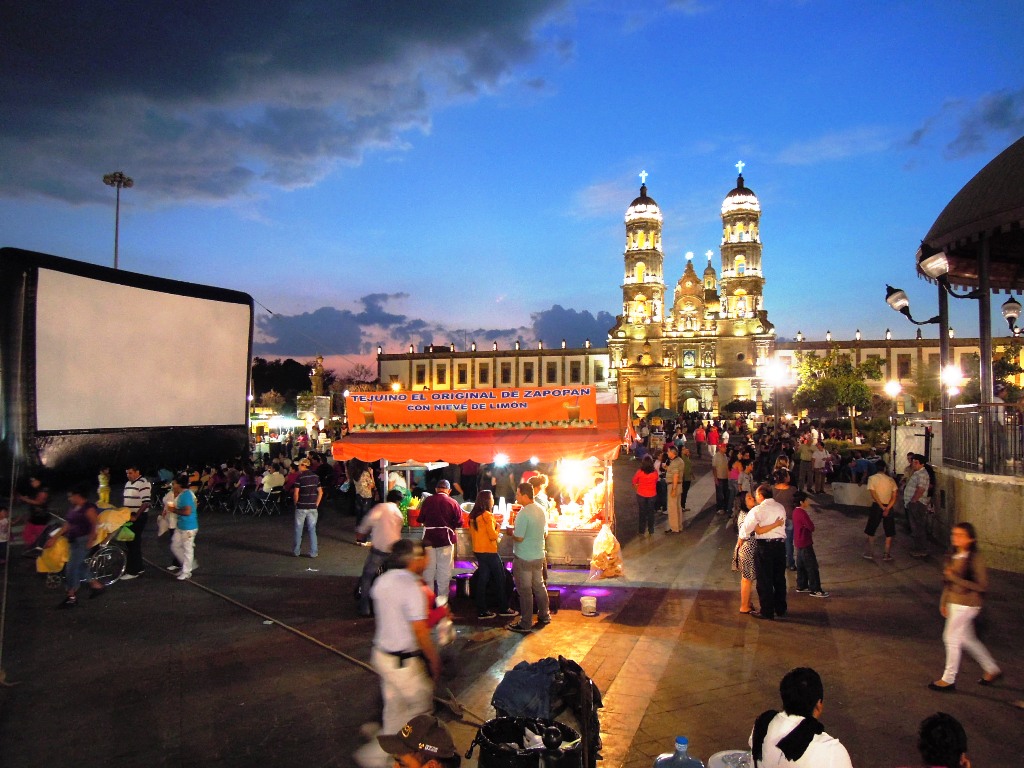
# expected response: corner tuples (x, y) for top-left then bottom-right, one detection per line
(345, 386), (597, 432)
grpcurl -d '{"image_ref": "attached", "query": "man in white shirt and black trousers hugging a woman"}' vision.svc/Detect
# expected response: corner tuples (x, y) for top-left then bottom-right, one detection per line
(740, 482), (788, 621)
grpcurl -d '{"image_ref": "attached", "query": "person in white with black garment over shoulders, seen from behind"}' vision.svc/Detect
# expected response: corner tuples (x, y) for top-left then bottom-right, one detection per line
(749, 667), (853, 768)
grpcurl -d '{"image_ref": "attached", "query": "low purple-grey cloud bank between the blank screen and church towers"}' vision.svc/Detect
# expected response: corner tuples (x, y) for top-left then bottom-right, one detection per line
(253, 293), (614, 358)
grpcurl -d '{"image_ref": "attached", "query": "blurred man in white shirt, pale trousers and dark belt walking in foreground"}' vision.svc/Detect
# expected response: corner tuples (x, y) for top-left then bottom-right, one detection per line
(352, 539), (441, 768)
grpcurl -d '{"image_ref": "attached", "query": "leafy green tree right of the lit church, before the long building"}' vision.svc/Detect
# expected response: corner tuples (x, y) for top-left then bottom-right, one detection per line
(793, 346), (882, 435)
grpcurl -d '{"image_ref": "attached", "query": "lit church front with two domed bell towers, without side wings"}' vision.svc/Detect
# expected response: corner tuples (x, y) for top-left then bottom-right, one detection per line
(608, 169), (775, 416)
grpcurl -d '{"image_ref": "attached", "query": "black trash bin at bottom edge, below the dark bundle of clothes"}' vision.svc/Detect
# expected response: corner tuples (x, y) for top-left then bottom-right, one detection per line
(466, 718), (583, 768)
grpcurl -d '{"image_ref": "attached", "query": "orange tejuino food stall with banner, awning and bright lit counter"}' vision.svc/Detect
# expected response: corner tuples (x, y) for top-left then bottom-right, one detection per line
(333, 385), (626, 565)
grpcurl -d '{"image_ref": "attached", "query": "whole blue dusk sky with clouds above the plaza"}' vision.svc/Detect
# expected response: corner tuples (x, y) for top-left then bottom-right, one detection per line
(0, 0), (1024, 370)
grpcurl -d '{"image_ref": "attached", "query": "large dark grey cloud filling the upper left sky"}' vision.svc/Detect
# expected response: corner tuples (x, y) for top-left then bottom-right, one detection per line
(0, 0), (564, 203)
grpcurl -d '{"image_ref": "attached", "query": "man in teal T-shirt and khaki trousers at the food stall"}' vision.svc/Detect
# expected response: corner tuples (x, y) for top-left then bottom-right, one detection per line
(505, 482), (551, 635)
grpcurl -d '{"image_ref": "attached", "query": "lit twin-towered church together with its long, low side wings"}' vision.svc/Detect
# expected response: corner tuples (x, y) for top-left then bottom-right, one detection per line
(377, 168), (995, 417)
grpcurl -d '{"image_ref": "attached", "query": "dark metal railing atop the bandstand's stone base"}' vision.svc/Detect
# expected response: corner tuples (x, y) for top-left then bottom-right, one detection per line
(942, 402), (1024, 475)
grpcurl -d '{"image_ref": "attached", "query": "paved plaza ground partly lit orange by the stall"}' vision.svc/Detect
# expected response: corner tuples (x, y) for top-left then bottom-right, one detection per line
(0, 460), (1024, 768)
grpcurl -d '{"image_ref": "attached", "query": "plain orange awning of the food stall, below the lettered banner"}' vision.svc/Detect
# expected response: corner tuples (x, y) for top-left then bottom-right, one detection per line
(333, 404), (627, 464)
